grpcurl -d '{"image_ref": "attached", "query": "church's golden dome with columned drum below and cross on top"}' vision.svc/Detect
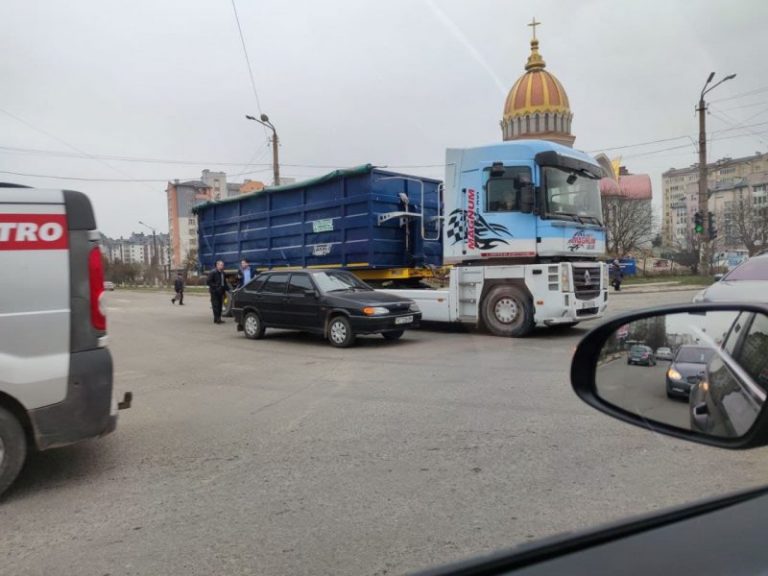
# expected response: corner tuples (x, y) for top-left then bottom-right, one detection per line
(501, 18), (576, 146)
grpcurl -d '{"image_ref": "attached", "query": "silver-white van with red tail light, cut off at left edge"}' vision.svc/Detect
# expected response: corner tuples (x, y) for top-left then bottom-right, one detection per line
(0, 183), (131, 494)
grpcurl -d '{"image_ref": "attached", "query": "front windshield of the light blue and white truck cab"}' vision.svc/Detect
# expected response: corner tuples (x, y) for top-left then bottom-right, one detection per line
(543, 166), (603, 224)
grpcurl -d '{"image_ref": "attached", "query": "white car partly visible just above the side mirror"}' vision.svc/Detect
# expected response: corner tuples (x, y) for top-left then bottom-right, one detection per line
(693, 252), (768, 302)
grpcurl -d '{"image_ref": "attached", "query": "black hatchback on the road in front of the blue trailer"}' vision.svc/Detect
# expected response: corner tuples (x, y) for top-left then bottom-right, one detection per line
(232, 270), (421, 348)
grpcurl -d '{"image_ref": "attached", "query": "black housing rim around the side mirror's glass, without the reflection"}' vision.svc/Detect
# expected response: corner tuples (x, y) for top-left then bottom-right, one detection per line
(571, 303), (768, 449)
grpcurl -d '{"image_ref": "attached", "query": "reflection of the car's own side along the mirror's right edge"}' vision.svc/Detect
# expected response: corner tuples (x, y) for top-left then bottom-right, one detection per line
(689, 312), (768, 438)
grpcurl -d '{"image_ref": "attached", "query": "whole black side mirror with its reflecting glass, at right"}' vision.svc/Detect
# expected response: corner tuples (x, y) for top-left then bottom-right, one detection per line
(571, 304), (768, 449)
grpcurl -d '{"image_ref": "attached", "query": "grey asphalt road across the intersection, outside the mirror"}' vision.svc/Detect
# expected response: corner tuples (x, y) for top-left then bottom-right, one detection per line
(0, 291), (768, 576)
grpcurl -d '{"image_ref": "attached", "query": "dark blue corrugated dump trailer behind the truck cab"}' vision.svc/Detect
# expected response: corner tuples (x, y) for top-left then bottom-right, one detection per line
(193, 164), (443, 283)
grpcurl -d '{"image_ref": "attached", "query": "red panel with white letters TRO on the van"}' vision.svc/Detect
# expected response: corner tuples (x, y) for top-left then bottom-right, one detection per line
(0, 214), (69, 250)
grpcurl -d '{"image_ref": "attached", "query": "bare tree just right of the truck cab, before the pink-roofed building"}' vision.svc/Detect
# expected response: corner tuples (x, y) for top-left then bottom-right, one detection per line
(603, 195), (653, 256)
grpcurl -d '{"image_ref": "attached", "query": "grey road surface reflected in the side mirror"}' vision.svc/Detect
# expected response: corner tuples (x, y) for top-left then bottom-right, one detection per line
(595, 355), (691, 430)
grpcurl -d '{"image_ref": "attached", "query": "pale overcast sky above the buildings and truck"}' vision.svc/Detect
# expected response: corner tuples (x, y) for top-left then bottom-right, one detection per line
(0, 0), (768, 236)
